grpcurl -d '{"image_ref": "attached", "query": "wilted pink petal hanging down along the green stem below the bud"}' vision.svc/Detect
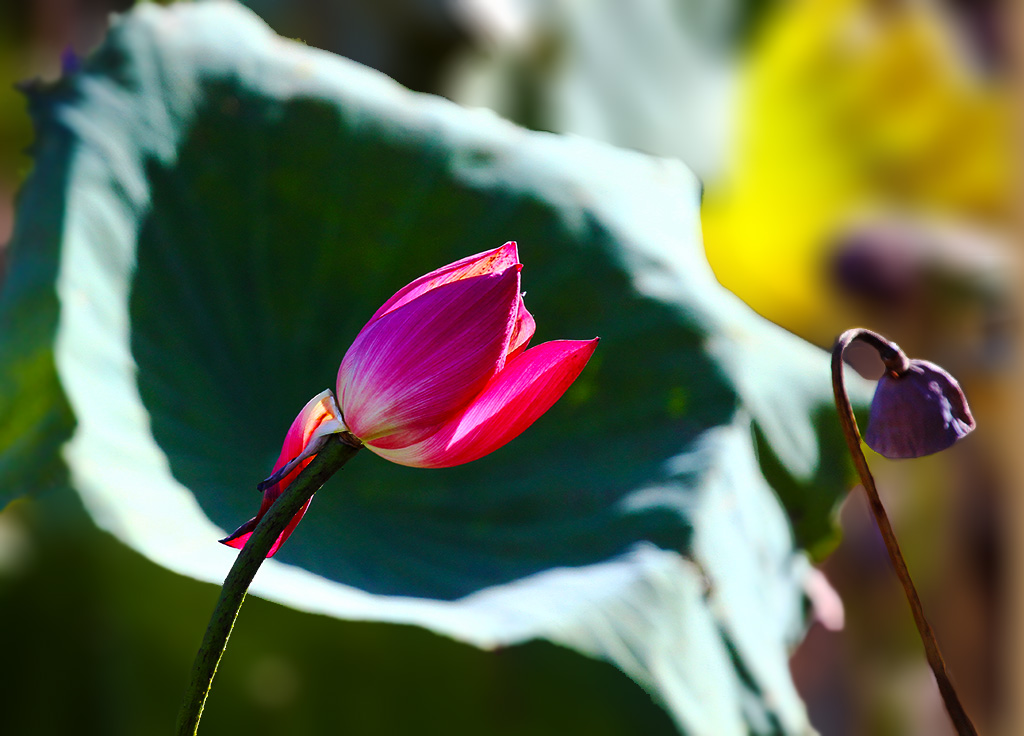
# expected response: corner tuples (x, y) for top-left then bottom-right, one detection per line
(220, 389), (346, 557)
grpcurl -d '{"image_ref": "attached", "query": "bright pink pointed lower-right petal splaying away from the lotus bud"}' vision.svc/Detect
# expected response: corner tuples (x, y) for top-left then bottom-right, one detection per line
(367, 338), (597, 468)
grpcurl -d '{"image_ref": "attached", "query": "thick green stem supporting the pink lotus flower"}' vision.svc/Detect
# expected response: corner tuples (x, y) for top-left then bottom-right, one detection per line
(178, 434), (359, 736)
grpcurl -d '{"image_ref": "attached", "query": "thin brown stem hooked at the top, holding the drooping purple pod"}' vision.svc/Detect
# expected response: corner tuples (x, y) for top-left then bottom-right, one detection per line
(831, 328), (978, 736)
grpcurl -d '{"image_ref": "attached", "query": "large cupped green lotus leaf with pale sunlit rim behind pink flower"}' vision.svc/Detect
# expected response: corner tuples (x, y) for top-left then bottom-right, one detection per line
(0, 3), (864, 736)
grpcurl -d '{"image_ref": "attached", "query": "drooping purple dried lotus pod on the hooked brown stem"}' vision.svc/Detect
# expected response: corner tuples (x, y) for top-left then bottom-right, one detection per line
(864, 360), (975, 459)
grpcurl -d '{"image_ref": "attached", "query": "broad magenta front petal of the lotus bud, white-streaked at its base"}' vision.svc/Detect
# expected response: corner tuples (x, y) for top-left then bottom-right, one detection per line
(338, 264), (521, 447)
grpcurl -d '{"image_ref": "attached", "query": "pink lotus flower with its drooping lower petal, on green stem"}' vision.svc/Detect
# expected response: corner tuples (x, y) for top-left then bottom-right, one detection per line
(222, 242), (597, 555)
